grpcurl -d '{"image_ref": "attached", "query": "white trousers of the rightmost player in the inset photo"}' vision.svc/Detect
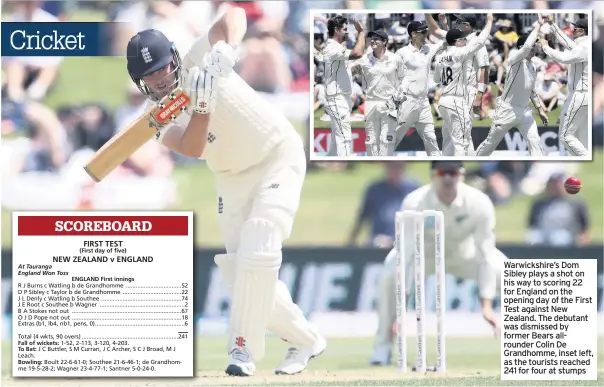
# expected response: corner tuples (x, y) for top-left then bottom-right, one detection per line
(558, 91), (591, 156)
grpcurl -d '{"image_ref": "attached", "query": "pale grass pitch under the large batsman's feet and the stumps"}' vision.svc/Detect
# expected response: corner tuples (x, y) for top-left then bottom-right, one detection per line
(2, 337), (604, 387)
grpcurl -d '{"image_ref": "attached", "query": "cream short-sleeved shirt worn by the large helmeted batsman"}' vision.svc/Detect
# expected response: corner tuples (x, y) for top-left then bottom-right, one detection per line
(156, 32), (298, 173)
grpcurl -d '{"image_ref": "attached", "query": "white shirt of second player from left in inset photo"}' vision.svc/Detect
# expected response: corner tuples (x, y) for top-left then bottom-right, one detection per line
(351, 51), (402, 101)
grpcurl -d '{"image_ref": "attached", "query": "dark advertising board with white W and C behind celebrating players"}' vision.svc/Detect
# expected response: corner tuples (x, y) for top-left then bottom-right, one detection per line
(396, 126), (562, 155)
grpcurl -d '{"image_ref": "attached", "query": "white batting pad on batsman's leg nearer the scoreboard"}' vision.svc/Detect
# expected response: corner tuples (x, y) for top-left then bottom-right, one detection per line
(230, 252), (281, 362)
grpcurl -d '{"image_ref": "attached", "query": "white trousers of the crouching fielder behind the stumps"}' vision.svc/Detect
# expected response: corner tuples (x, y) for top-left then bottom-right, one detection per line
(374, 249), (506, 348)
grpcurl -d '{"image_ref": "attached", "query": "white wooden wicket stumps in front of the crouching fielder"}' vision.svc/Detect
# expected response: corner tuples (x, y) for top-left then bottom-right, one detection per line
(395, 210), (447, 373)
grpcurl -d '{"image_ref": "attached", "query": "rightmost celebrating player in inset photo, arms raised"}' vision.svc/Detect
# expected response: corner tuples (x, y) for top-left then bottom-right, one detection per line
(540, 15), (591, 156)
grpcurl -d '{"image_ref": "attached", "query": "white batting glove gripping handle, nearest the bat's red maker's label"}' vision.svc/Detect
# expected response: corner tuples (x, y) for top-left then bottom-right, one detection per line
(185, 66), (218, 114)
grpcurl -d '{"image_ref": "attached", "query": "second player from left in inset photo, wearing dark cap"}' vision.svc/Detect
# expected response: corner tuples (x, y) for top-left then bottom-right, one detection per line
(351, 31), (403, 156)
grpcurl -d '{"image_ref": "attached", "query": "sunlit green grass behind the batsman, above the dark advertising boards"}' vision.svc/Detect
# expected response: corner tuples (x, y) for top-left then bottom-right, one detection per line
(2, 151), (604, 246)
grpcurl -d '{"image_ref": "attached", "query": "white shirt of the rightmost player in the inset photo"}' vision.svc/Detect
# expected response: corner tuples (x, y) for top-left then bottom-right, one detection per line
(543, 23), (592, 91)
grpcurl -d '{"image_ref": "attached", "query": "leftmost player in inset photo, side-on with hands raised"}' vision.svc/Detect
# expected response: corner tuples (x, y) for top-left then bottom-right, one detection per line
(323, 15), (365, 157)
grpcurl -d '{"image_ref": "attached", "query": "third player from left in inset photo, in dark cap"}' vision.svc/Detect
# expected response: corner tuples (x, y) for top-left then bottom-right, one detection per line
(394, 19), (443, 156)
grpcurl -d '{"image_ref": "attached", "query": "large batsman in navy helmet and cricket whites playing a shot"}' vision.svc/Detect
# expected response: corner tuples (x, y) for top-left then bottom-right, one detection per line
(127, 6), (326, 376)
